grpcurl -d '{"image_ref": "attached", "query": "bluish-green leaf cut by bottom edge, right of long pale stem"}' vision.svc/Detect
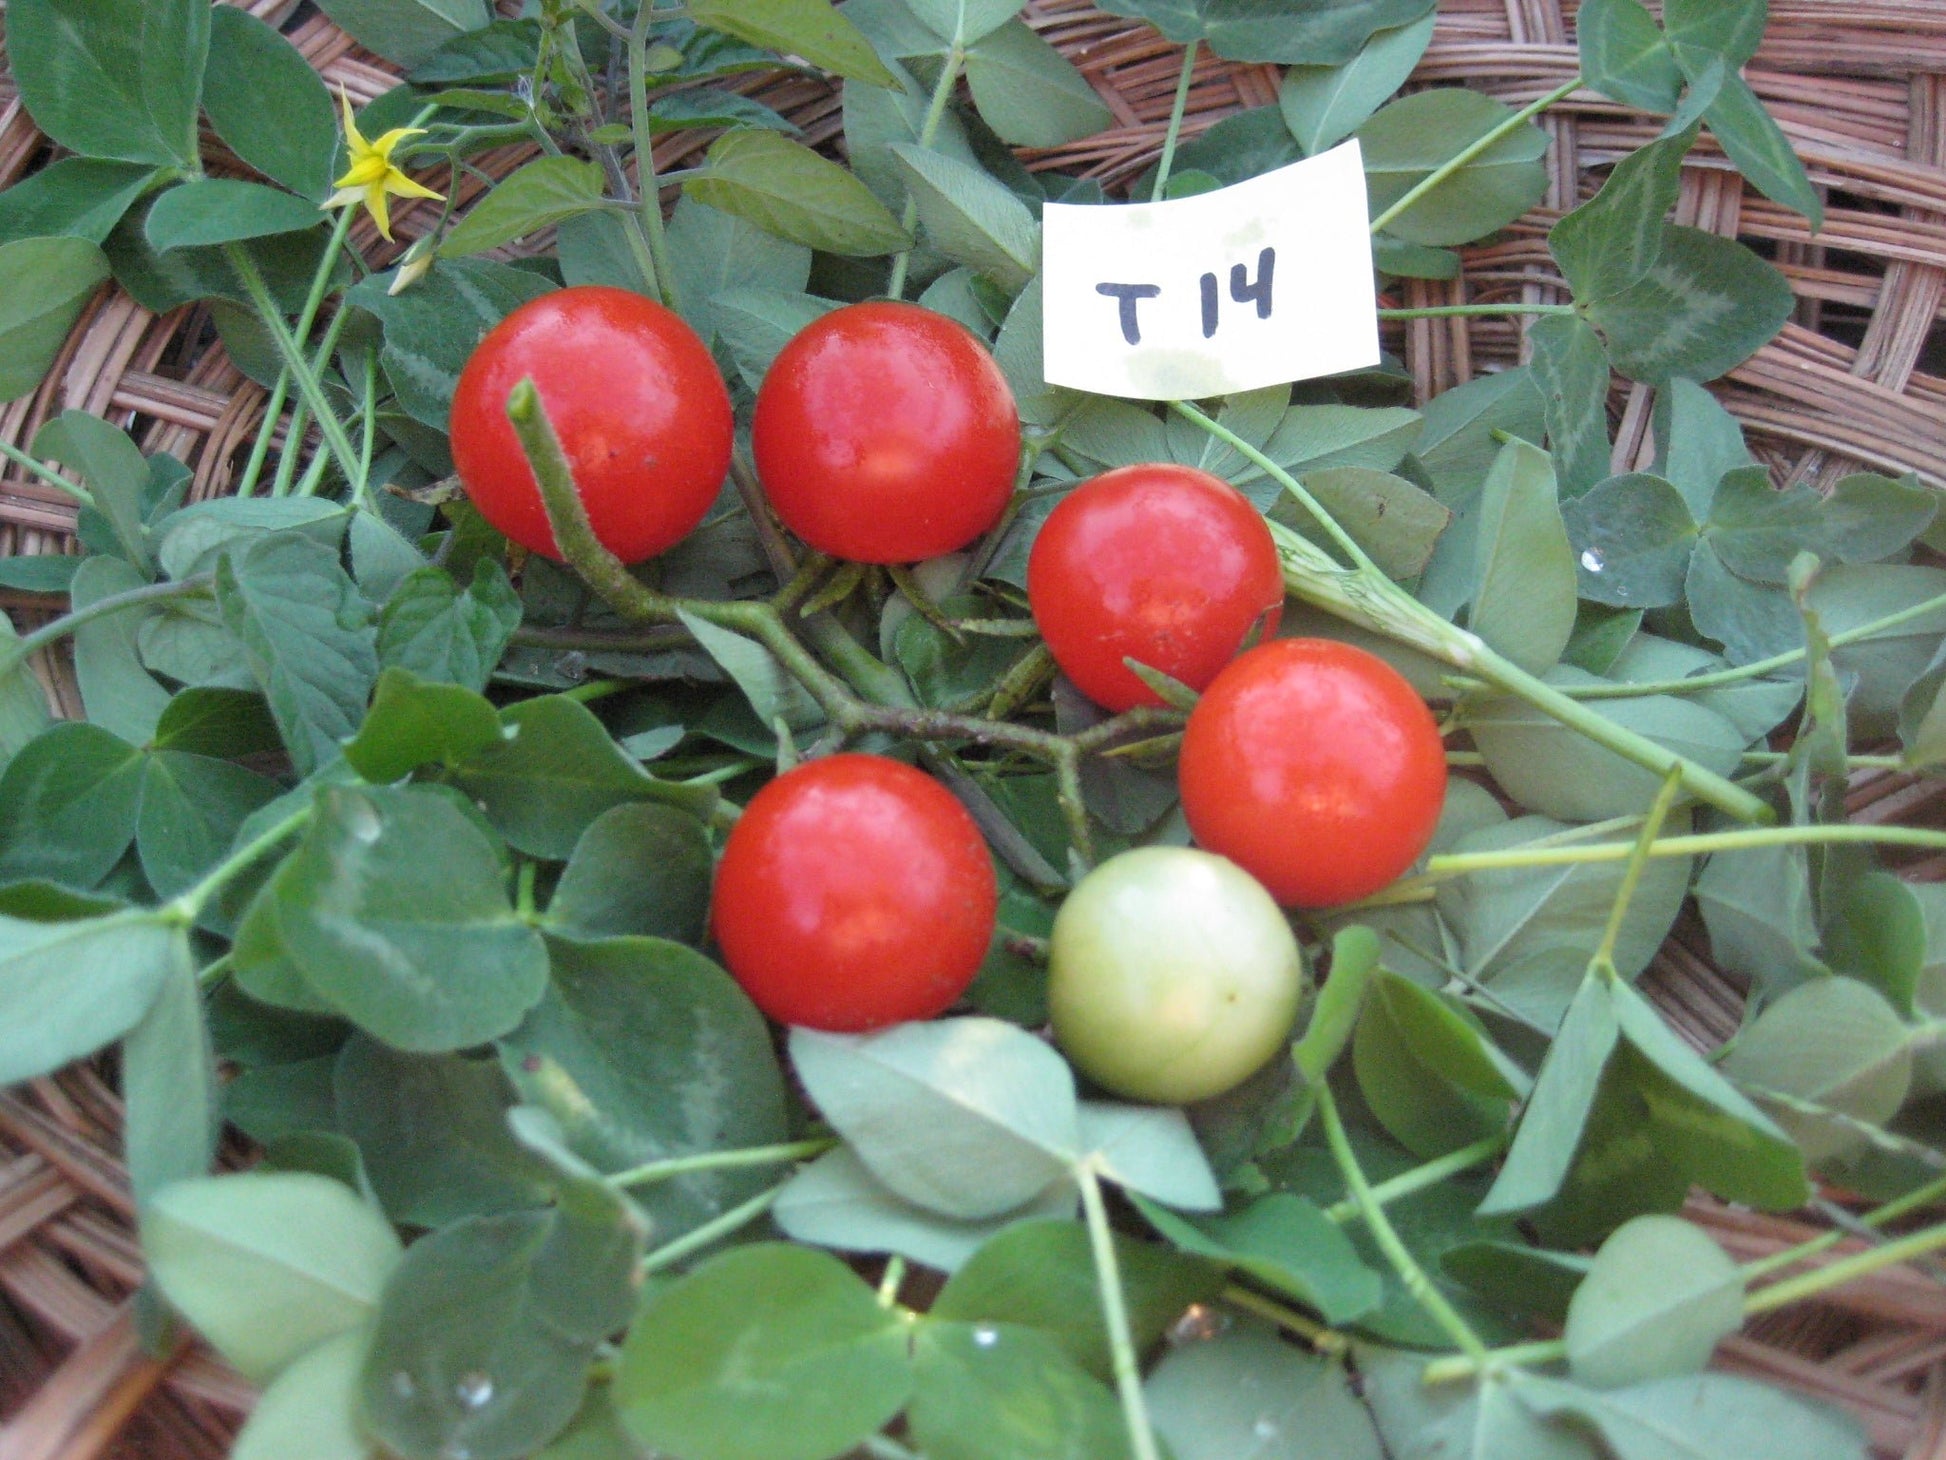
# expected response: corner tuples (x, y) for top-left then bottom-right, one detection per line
(1142, 1324), (1387, 1460)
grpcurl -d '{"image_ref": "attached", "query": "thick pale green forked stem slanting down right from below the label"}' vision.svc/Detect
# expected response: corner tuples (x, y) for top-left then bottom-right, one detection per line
(1170, 401), (1775, 823)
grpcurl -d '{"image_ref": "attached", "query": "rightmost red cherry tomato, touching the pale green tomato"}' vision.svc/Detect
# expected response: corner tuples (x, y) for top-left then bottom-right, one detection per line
(1177, 639), (1446, 907)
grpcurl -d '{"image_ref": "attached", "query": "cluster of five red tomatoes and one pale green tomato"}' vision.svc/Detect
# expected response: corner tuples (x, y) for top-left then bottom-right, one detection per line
(451, 288), (1446, 1102)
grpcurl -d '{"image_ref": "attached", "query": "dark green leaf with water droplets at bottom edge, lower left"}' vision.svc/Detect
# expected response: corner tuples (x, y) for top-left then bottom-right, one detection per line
(358, 1207), (632, 1460)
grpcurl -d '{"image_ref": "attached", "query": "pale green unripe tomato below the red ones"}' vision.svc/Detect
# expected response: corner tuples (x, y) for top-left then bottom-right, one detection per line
(1047, 847), (1304, 1104)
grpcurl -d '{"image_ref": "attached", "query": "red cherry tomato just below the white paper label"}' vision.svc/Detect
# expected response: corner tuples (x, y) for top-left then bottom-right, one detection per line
(1027, 463), (1284, 711)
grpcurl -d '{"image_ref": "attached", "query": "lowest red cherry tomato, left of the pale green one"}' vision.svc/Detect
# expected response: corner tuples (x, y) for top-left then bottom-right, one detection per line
(710, 755), (998, 1032)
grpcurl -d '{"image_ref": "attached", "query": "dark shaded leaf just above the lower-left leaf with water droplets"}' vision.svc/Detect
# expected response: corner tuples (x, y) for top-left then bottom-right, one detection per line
(331, 1034), (547, 1226)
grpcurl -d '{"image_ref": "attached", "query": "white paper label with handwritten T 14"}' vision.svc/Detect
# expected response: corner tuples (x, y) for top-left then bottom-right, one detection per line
(1041, 140), (1380, 401)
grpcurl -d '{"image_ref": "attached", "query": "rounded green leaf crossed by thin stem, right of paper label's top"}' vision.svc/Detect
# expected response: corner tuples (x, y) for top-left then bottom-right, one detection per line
(1358, 86), (1547, 247)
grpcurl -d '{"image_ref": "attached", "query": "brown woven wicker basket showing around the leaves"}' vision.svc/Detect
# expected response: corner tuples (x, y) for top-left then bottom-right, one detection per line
(0, 0), (1946, 1460)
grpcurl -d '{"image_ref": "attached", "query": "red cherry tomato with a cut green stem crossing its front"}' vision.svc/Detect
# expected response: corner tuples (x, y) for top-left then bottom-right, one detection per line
(451, 284), (734, 563)
